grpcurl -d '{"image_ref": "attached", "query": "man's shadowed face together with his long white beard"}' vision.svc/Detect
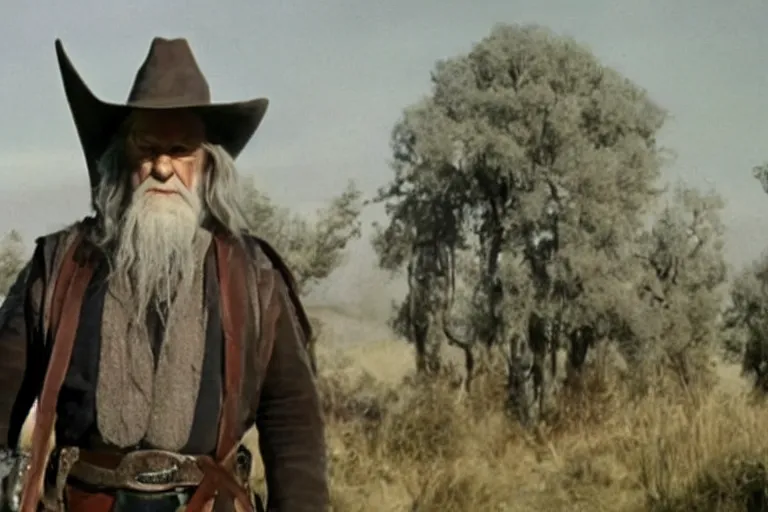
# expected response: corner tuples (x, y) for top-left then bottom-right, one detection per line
(109, 111), (206, 318)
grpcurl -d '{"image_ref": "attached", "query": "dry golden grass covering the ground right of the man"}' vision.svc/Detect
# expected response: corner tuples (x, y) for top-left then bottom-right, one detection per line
(248, 336), (768, 512)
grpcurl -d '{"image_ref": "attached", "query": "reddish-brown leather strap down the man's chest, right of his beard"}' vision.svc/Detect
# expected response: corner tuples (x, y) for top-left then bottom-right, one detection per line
(186, 235), (253, 512)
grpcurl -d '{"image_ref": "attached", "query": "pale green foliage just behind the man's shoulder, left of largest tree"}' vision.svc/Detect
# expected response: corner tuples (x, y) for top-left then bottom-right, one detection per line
(242, 180), (362, 293)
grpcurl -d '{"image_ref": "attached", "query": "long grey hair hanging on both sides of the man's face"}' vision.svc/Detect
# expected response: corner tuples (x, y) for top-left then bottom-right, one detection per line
(92, 138), (249, 253)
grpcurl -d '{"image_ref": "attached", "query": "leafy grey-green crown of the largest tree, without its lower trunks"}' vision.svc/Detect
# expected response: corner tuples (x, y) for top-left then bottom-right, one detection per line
(376, 26), (664, 344)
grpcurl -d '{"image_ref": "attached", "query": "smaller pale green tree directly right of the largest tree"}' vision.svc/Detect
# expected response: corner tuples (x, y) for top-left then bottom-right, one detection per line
(624, 186), (726, 384)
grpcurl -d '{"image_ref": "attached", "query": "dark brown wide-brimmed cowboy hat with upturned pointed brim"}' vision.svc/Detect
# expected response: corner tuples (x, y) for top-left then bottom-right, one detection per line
(56, 37), (269, 189)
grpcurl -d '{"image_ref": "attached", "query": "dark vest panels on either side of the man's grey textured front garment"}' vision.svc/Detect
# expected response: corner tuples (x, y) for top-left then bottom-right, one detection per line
(56, 244), (224, 455)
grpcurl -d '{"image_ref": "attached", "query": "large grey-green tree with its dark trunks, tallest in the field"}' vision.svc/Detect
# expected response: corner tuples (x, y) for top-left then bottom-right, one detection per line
(374, 25), (680, 422)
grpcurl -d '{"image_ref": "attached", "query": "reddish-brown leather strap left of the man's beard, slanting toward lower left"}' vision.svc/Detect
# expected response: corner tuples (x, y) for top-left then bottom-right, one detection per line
(20, 235), (93, 512)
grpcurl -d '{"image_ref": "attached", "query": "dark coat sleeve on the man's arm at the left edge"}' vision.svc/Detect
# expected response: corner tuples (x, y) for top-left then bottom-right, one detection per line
(0, 245), (45, 448)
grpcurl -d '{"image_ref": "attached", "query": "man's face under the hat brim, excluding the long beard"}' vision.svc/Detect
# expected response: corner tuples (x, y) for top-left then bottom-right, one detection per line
(126, 110), (205, 194)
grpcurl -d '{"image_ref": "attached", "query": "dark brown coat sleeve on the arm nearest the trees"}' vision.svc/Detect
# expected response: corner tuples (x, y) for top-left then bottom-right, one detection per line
(256, 272), (329, 512)
